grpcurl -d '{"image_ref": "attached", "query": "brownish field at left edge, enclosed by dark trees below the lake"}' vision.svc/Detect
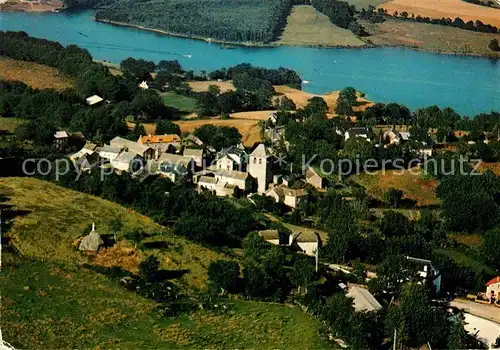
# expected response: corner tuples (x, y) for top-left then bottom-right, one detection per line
(0, 57), (73, 90)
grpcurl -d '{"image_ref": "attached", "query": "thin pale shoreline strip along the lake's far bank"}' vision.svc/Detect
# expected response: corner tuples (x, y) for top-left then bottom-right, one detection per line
(93, 16), (500, 60)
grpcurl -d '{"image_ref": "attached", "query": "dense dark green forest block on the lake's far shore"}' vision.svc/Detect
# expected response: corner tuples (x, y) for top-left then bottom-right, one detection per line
(96, 0), (293, 42)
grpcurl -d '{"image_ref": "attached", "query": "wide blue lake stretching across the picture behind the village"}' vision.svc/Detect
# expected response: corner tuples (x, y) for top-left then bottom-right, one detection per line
(0, 11), (500, 116)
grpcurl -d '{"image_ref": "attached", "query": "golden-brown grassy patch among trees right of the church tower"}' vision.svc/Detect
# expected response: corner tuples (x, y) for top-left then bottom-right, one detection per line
(354, 169), (440, 206)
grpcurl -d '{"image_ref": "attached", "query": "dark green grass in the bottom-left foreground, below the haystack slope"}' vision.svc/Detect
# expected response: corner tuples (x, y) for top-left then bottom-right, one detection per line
(0, 260), (328, 349)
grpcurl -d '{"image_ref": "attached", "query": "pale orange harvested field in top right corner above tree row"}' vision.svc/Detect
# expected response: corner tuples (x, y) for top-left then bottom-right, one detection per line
(378, 0), (500, 27)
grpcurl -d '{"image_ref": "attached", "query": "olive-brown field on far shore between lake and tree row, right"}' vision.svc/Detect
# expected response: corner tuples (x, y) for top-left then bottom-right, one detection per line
(361, 19), (500, 57)
